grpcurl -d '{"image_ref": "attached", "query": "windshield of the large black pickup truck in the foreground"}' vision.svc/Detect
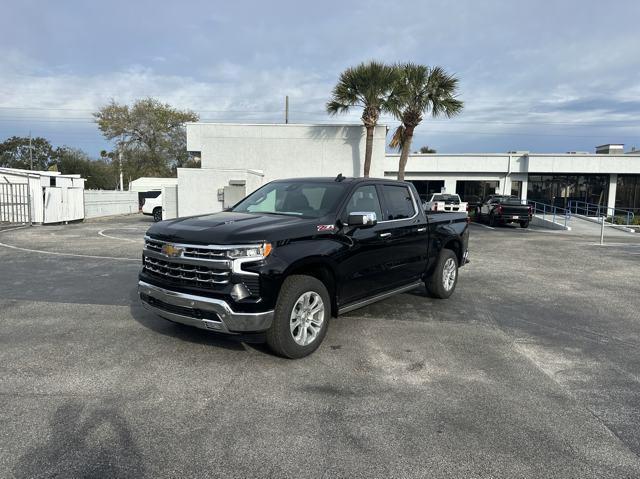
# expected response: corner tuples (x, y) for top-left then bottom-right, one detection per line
(231, 181), (344, 218)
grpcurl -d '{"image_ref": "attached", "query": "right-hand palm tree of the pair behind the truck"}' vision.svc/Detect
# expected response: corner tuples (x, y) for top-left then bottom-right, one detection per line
(389, 63), (464, 180)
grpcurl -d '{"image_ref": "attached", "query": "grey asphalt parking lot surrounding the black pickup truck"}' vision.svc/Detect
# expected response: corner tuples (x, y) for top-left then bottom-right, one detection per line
(0, 215), (640, 478)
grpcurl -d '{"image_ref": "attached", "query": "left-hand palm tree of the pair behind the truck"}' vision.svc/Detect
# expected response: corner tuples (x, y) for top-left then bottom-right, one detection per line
(327, 61), (399, 177)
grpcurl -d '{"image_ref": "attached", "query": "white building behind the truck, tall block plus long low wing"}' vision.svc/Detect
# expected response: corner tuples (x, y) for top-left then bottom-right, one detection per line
(172, 123), (640, 216)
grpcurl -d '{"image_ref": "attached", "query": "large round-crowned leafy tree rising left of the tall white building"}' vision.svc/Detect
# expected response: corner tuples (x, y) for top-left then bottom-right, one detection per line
(94, 98), (199, 177)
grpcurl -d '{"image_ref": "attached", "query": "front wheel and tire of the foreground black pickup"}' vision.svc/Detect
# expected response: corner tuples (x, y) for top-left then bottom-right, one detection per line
(266, 275), (331, 359)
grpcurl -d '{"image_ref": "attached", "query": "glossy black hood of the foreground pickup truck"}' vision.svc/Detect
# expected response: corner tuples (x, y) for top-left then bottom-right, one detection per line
(147, 212), (324, 244)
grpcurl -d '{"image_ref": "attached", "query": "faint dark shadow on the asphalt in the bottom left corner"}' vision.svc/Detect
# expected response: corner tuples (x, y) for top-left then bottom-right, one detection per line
(12, 399), (145, 478)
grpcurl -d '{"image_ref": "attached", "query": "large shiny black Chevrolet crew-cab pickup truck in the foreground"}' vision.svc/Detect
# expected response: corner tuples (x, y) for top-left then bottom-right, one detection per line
(138, 175), (469, 358)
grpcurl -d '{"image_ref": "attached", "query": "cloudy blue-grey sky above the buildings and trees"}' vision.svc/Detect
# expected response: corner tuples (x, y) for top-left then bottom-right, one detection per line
(0, 0), (640, 157)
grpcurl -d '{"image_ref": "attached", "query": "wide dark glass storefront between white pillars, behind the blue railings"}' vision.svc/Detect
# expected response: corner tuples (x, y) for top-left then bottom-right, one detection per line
(527, 175), (609, 208)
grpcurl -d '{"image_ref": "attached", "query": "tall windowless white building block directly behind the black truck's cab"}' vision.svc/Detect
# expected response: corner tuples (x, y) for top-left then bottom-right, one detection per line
(178, 123), (386, 216)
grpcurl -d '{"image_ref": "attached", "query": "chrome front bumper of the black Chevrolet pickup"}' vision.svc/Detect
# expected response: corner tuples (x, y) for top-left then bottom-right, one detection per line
(138, 281), (273, 334)
